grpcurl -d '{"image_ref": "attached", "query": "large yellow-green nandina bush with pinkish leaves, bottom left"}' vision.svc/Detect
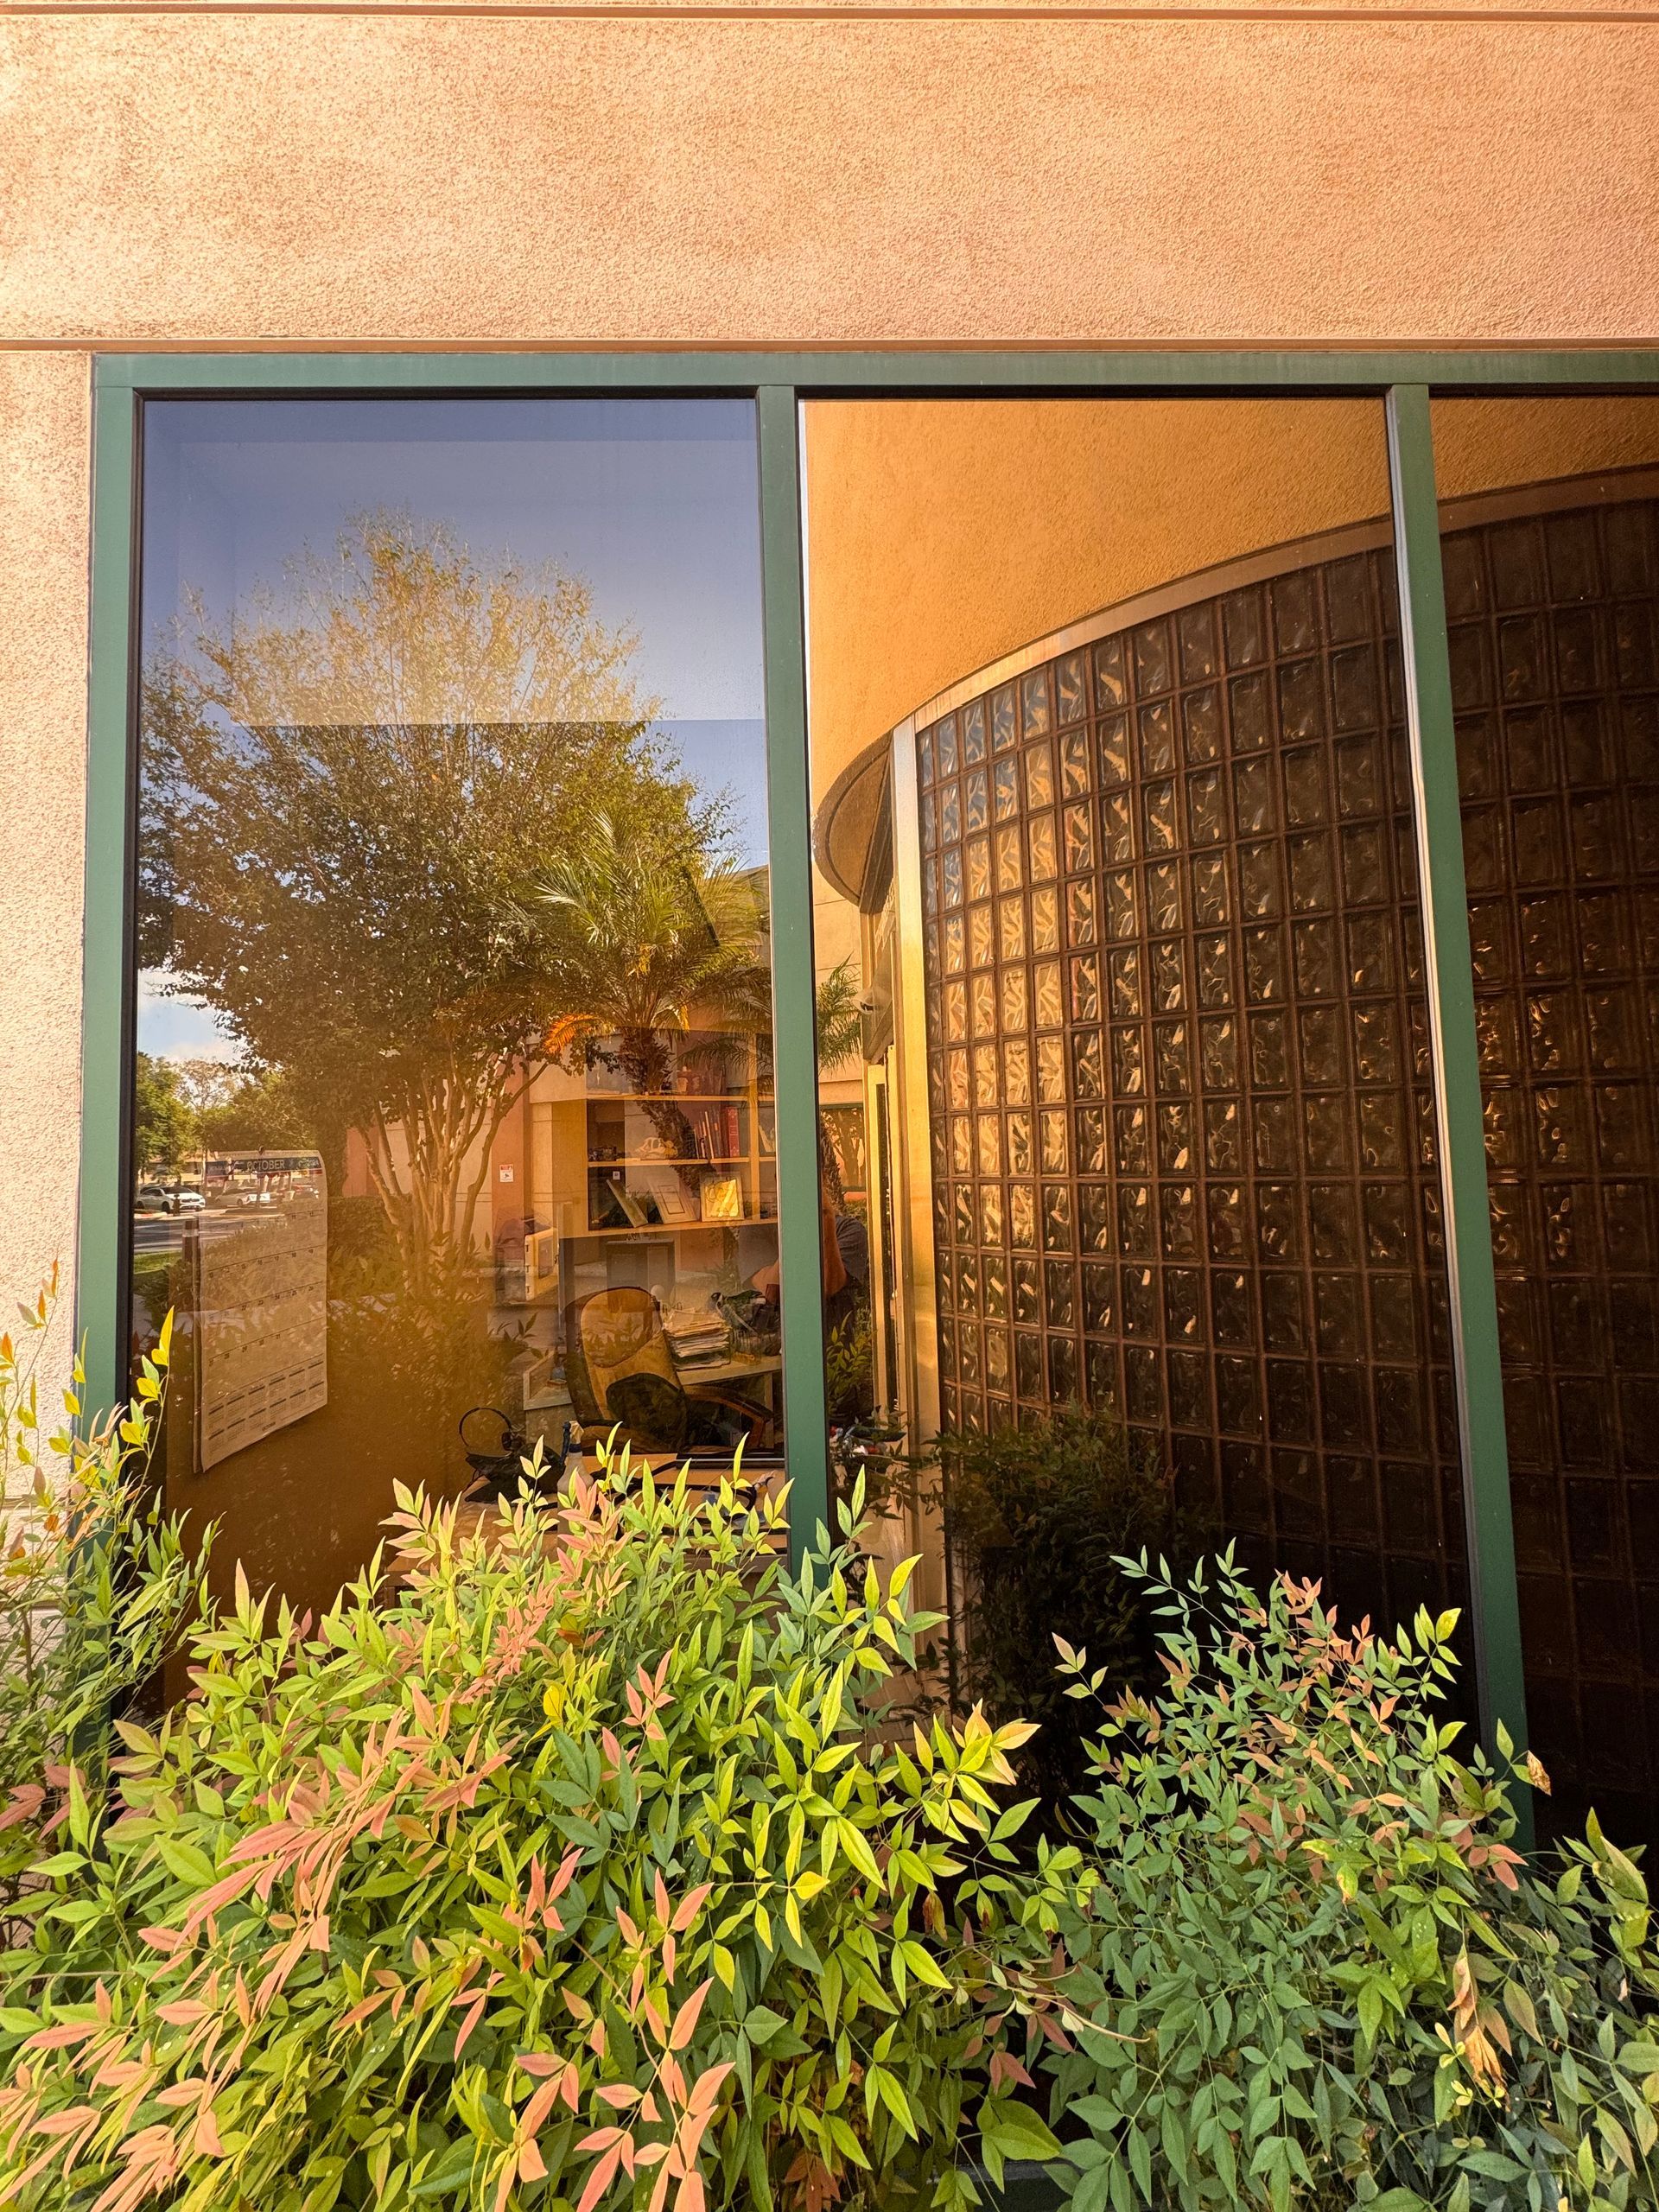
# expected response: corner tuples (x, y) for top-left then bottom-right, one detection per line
(0, 1460), (1053, 2212)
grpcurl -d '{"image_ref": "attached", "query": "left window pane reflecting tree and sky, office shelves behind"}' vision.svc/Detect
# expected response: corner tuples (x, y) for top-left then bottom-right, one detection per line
(130, 400), (781, 1604)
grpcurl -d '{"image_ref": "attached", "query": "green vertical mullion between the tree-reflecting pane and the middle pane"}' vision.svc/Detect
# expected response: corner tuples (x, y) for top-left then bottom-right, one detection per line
(759, 385), (830, 1561)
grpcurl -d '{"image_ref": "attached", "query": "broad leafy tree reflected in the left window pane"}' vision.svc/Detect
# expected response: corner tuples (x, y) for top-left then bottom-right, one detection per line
(139, 513), (739, 1272)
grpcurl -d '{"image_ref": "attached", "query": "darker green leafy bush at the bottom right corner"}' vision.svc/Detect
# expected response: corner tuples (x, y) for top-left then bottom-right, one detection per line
(1008, 1557), (1659, 2212)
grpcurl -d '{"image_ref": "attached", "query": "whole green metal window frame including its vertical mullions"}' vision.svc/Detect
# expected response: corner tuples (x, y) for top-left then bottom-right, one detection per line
(75, 347), (1659, 1745)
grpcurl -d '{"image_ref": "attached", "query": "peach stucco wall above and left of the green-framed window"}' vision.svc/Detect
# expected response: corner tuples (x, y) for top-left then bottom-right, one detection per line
(0, 0), (1659, 1344)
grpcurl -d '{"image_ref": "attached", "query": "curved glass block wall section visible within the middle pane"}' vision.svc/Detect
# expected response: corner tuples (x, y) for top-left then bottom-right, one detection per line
(916, 550), (1462, 1619)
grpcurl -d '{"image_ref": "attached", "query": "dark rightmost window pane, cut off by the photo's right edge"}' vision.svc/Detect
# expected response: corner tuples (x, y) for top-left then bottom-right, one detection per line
(1433, 398), (1659, 1840)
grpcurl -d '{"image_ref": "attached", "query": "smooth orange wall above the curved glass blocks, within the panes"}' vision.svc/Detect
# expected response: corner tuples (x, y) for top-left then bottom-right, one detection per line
(805, 398), (1659, 798)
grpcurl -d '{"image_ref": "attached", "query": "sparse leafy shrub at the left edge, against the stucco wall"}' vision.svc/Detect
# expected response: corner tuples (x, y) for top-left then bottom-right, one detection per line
(0, 1269), (193, 1916)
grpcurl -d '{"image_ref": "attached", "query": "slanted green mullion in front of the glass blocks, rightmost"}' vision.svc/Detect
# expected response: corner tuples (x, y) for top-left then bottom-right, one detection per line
(1387, 385), (1526, 1778)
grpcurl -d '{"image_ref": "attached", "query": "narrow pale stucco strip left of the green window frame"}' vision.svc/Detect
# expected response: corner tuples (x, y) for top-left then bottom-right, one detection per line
(0, 354), (91, 1407)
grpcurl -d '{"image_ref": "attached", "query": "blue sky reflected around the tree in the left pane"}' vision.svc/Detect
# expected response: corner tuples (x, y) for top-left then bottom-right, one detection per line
(139, 398), (766, 1055)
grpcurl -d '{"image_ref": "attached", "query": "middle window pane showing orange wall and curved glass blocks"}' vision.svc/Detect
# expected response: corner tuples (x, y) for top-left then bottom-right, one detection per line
(805, 400), (1465, 1792)
